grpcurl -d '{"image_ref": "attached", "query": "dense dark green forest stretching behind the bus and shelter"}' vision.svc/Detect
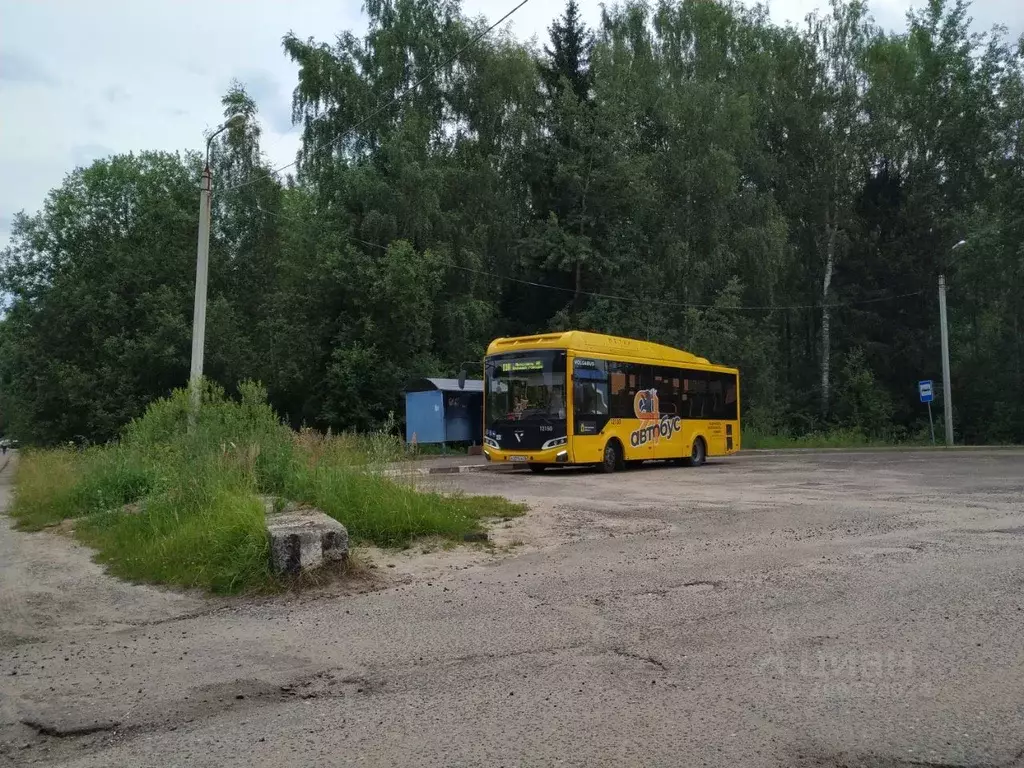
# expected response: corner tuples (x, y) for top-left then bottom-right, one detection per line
(0, 0), (1024, 443)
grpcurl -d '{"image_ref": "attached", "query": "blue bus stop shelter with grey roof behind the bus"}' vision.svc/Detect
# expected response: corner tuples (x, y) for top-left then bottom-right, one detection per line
(406, 379), (483, 445)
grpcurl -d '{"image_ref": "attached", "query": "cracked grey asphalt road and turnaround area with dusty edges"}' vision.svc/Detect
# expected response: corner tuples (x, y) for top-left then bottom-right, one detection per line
(0, 451), (1024, 768)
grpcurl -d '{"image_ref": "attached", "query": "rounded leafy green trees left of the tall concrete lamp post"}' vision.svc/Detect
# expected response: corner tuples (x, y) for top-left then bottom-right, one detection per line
(0, 153), (199, 442)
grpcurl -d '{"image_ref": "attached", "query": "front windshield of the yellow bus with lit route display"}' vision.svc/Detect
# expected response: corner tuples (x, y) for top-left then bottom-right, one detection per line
(484, 350), (565, 424)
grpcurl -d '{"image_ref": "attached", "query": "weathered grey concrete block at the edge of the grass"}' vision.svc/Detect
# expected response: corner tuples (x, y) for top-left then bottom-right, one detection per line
(266, 507), (348, 574)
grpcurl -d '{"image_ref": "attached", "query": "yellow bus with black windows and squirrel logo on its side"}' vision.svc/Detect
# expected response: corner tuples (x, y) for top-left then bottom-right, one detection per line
(475, 331), (740, 472)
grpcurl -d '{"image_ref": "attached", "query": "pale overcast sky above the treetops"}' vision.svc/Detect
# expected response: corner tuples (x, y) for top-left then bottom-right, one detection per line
(0, 0), (1024, 247)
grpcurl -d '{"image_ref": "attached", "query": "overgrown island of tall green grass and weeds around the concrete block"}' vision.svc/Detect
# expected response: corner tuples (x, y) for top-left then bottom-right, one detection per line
(11, 384), (525, 593)
